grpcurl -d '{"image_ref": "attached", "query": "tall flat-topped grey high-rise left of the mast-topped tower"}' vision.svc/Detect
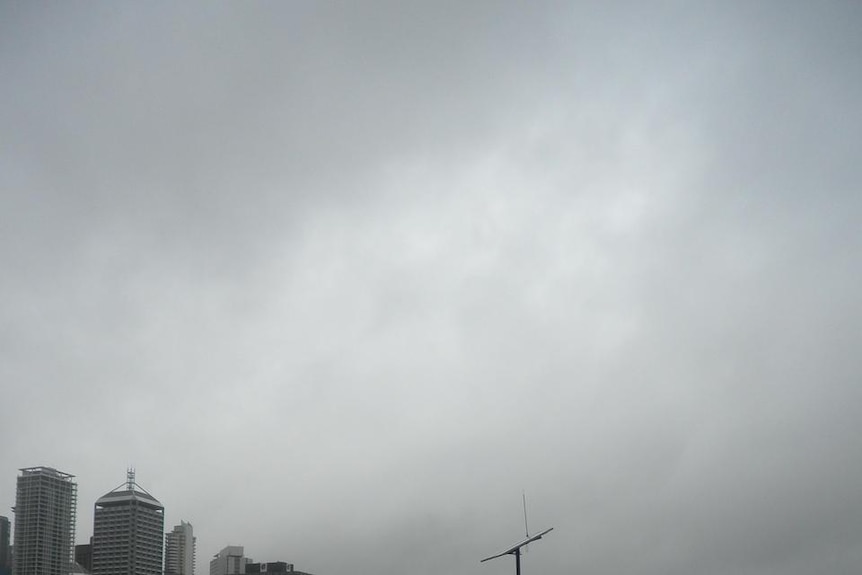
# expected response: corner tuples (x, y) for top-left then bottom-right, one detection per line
(14, 467), (78, 575)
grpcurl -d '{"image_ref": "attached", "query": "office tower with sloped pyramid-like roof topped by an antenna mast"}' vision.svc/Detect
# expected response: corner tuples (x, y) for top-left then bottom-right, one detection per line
(92, 469), (165, 575)
